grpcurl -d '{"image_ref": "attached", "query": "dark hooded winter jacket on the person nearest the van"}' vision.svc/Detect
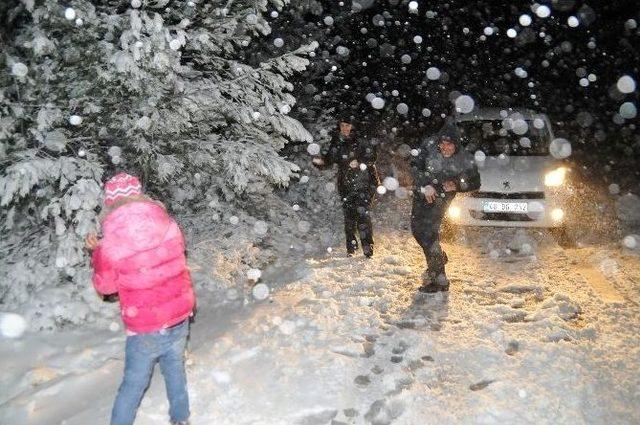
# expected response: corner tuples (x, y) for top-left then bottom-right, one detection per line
(411, 123), (480, 196)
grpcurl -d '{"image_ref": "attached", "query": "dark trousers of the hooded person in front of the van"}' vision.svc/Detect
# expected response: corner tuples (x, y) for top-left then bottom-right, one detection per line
(411, 193), (453, 276)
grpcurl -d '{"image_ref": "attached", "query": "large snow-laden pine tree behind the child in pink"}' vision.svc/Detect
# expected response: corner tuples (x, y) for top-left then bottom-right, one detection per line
(0, 0), (316, 328)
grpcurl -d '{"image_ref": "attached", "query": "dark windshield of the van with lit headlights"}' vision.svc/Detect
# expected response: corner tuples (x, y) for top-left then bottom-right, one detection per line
(458, 120), (550, 156)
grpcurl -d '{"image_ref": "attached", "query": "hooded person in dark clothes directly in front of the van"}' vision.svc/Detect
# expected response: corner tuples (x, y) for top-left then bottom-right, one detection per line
(411, 121), (480, 293)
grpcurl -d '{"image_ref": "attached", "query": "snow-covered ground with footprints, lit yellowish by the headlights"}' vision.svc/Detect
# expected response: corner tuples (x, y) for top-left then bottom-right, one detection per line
(0, 199), (640, 425)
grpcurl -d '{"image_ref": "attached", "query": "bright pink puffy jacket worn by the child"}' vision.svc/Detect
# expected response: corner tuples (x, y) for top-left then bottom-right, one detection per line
(92, 201), (195, 333)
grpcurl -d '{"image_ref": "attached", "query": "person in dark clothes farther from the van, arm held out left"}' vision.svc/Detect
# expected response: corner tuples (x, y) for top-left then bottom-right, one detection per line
(313, 117), (380, 257)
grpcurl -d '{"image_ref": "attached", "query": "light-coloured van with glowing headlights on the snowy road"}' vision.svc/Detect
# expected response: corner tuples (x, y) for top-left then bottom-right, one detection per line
(447, 109), (571, 233)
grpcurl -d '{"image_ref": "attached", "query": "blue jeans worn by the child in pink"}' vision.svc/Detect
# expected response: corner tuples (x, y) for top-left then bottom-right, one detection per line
(111, 320), (189, 425)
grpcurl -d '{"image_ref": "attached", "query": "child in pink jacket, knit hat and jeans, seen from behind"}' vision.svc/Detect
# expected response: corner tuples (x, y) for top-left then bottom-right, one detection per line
(87, 173), (195, 425)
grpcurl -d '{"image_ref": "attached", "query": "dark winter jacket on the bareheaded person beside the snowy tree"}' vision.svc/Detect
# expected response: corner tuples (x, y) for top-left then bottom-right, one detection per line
(322, 133), (380, 198)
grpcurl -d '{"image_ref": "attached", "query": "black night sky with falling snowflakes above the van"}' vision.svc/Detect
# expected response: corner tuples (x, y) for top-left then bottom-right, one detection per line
(274, 0), (640, 140)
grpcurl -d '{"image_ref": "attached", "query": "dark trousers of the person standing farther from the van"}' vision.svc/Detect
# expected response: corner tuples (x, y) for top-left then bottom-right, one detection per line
(342, 194), (373, 252)
